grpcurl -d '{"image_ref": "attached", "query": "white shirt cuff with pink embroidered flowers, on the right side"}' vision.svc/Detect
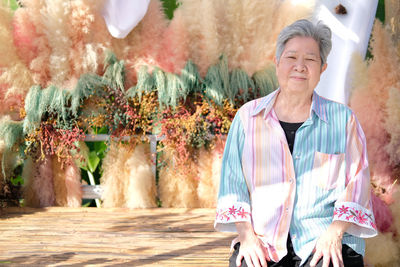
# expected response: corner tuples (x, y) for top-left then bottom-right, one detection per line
(333, 202), (378, 238)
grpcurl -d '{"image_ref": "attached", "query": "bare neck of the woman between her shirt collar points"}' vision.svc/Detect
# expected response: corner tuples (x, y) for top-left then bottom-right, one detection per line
(274, 90), (312, 122)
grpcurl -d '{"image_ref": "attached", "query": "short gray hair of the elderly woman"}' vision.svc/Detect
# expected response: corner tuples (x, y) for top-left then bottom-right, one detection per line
(275, 19), (332, 67)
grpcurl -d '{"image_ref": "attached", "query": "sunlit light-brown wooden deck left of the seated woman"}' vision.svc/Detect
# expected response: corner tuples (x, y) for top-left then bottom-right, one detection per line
(0, 208), (234, 267)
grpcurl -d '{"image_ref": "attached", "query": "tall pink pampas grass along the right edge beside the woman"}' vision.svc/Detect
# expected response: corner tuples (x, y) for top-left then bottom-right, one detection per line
(350, 21), (399, 194)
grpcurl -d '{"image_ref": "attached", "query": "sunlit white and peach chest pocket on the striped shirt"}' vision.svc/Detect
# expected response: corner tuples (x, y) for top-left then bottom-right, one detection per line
(312, 151), (345, 190)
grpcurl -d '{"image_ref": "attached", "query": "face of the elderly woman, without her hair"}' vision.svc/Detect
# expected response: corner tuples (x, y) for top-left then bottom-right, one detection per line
(275, 37), (326, 95)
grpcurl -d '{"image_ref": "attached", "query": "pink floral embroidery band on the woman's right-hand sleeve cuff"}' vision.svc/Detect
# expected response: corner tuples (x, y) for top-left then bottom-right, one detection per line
(333, 205), (376, 229)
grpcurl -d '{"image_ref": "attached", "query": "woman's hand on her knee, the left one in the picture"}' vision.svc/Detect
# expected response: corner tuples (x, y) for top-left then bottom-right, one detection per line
(236, 222), (270, 267)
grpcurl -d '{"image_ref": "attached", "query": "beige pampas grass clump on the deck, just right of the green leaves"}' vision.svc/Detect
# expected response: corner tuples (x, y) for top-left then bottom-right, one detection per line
(101, 144), (156, 209)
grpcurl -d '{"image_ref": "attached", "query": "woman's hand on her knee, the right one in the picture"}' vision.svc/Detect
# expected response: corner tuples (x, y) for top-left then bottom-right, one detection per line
(310, 221), (351, 267)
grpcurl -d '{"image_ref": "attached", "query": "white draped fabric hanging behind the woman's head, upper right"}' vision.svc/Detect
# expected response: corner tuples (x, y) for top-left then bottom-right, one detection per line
(313, 0), (378, 104)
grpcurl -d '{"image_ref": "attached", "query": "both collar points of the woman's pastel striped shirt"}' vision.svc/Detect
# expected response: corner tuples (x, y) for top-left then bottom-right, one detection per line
(251, 88), (328, 123)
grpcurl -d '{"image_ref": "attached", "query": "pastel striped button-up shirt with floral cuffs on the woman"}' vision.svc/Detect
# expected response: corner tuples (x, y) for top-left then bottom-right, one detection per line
(215, 89), (377, 264)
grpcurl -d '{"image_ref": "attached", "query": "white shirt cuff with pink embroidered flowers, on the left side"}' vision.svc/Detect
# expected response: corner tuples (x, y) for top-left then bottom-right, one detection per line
(214, 202), (251, 232)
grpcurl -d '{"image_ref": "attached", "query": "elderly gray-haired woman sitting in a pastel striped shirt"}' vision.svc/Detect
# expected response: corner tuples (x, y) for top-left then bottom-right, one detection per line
(215, 20), (377, 267)
